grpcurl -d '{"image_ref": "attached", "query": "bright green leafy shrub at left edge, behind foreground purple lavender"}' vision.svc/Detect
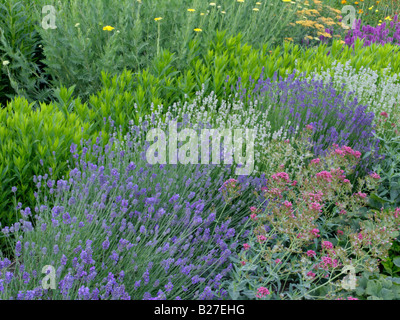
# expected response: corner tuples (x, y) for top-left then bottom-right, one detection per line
(0, 97), (104, 229)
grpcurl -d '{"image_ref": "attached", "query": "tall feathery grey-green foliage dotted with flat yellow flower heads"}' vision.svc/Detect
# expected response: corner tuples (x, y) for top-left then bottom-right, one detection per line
(25, 0), (297, 101)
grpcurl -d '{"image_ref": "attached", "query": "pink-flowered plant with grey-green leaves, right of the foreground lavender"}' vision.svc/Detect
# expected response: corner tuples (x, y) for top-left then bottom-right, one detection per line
(223, 132), (400, 299)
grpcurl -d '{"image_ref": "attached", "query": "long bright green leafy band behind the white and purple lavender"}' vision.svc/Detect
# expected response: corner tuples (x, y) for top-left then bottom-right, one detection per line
(65, 31), (400, 121)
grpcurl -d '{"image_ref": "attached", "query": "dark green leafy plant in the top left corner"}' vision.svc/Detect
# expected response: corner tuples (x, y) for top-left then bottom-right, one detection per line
(0, 0), (50, 105)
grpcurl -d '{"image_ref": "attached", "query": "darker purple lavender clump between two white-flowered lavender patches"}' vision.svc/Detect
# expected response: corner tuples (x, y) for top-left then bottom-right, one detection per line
(240, 71), (380, 176)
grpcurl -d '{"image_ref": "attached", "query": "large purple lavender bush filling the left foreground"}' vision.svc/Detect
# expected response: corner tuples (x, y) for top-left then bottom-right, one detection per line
(0, 119), (262, 300)
